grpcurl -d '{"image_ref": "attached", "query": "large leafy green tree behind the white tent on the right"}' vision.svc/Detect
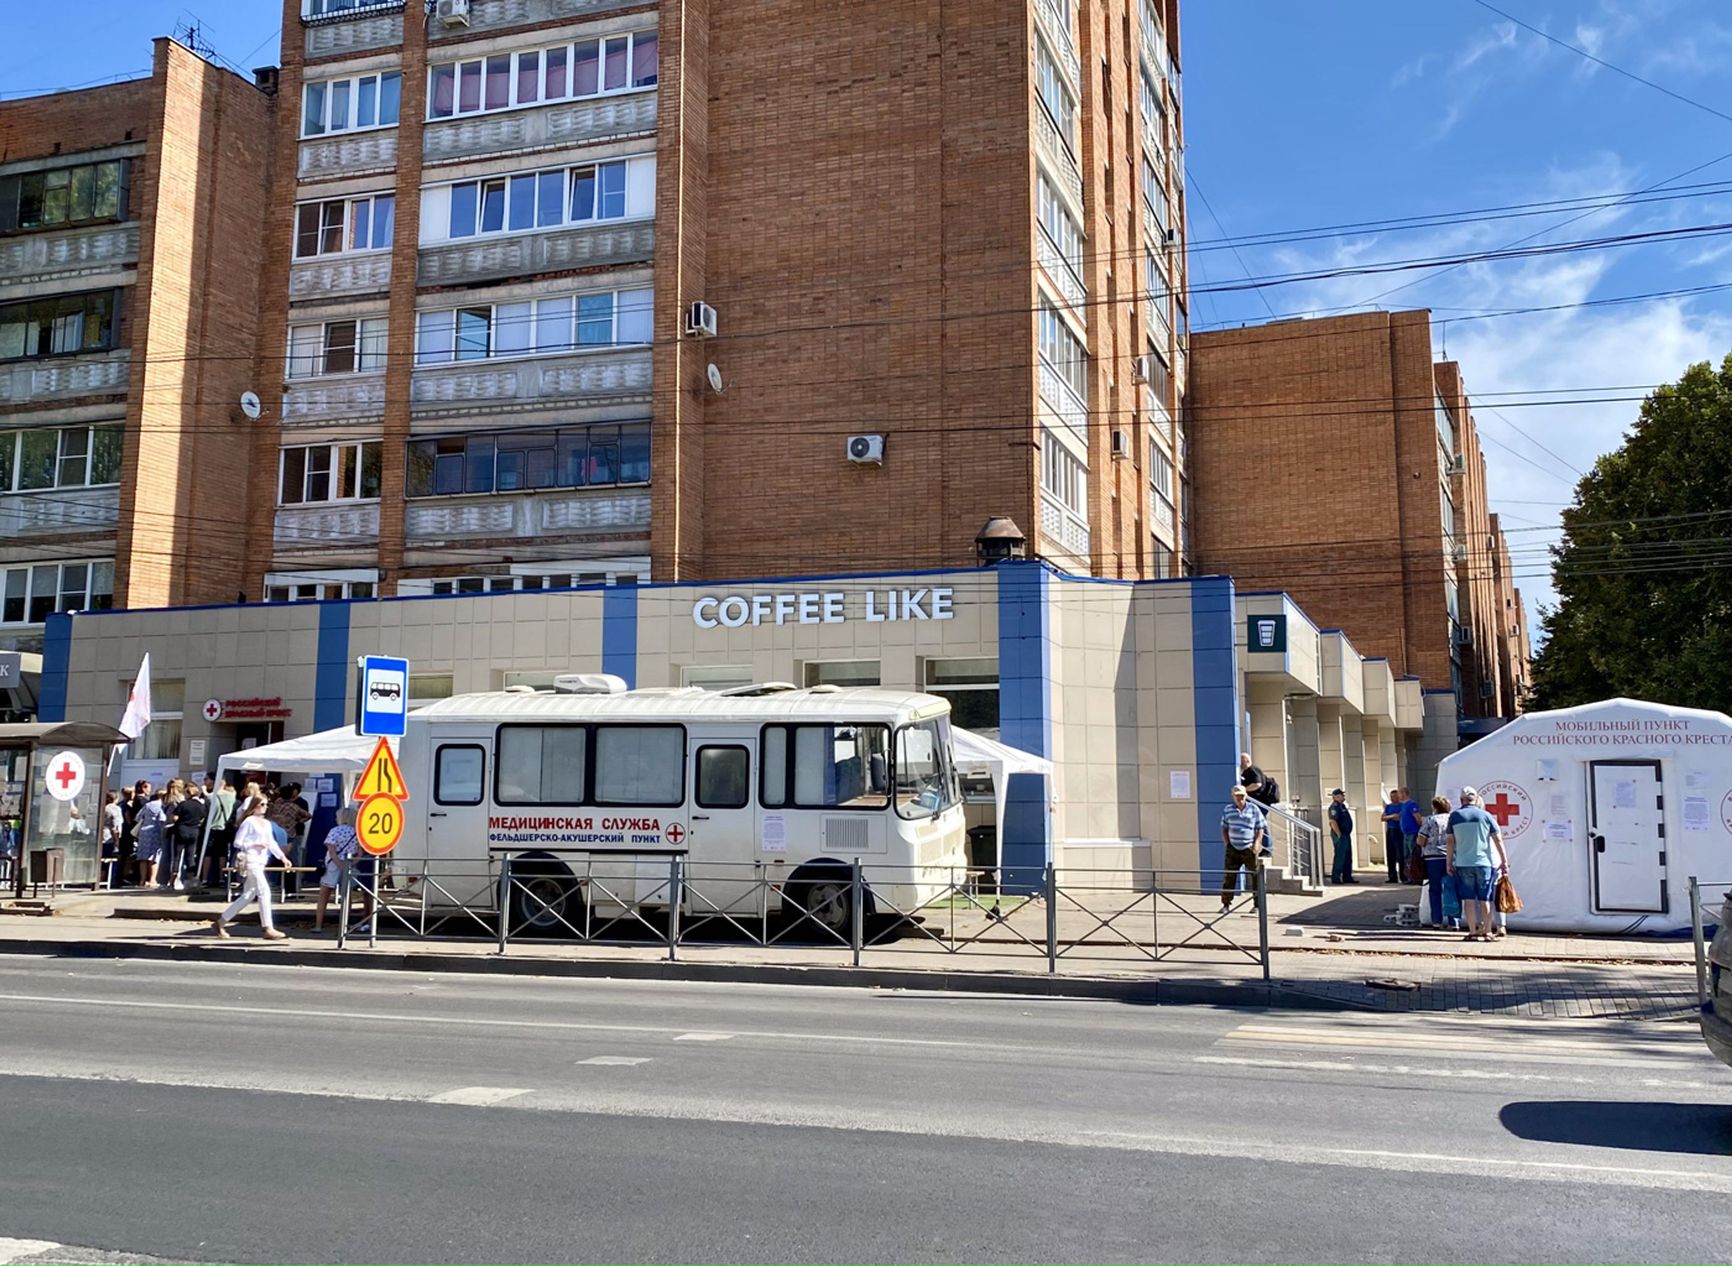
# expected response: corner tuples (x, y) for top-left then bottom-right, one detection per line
(1529, 355), (1732, 712)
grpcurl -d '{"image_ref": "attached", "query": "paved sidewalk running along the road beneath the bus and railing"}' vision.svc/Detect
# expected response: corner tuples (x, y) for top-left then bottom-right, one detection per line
(0, 890), (1696, 1020)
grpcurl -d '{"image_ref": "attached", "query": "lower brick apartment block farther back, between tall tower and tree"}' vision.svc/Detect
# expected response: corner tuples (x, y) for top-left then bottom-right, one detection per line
(1188, 312), (1528, 734)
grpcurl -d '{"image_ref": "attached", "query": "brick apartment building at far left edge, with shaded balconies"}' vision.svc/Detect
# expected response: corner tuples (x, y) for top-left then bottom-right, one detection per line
(0, 40), (274, 653)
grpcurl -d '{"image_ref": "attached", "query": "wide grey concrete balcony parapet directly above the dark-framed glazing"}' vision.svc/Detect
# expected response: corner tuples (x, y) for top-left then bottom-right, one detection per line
(409, 348), (650, 417)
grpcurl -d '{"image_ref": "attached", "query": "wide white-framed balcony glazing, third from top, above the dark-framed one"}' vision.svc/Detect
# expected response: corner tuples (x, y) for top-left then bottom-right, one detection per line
(416, 289), (653, 365)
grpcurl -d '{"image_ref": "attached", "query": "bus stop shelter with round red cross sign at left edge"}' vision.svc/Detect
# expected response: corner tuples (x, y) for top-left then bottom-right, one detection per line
(0, 720), (126, 897)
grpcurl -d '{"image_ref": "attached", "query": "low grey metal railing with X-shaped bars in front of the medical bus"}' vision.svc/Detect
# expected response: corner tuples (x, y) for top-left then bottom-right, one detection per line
(327, 849), (1270, 980)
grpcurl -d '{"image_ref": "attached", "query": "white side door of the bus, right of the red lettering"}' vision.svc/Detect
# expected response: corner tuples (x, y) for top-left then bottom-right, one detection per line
(686, 726), (760, 918)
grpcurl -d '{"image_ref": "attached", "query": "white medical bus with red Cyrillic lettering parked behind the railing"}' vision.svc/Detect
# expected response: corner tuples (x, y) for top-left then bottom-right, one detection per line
(393, 677), (966, 932)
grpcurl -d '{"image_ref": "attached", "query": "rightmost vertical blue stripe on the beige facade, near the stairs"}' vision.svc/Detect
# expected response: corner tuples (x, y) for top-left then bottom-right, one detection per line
(1192, 577), (1238, 869)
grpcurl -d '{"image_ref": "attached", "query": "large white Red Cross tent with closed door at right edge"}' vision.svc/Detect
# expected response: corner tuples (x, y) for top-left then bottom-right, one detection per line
(1438, 700), (1732, 933)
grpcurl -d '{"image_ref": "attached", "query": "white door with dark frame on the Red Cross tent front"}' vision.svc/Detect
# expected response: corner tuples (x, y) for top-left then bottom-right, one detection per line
(1588, 760), (1666, 914)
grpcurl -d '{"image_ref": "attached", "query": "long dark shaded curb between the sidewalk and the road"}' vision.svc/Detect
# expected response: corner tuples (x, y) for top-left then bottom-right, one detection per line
(0, 940), (1384, 1011)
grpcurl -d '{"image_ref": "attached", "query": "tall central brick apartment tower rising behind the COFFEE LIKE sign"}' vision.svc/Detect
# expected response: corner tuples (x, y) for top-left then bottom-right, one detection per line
(248, 0), (1186, 599)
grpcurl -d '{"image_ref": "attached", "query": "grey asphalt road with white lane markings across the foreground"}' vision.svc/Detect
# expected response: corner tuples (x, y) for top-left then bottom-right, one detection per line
(0, 959), (1732, 1263)
